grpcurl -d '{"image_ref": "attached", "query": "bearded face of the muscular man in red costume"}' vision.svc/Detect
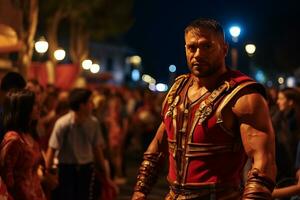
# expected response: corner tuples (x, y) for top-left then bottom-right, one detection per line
(185, 29), (228, 78)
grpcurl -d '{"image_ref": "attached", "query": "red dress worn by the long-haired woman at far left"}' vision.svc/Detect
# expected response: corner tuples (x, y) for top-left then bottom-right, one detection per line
(0, 132), (46, 200)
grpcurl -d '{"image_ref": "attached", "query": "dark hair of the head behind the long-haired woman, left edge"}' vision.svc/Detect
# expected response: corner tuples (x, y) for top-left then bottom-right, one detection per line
(1, 72), (26, 92)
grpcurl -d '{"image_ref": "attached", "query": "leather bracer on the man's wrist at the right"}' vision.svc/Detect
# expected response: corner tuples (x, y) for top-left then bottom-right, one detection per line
(242, 168), (275, 200)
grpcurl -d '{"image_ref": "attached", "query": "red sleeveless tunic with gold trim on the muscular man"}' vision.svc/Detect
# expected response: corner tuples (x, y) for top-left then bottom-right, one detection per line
(162, 71), (259, 186)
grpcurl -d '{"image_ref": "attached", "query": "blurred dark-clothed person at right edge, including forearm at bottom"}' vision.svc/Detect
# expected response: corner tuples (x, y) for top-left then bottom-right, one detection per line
(272, 88), (300, 200)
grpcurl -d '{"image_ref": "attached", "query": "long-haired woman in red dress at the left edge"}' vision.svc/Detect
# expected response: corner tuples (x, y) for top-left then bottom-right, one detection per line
(0, 89), (46, 200)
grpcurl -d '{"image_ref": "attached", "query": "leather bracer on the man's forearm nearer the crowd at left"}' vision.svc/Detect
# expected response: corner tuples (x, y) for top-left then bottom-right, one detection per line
(134, 153), (162, 195)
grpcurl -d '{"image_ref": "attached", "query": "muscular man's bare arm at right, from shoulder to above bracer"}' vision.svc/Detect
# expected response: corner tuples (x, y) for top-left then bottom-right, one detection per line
(232, 89), (276, 180)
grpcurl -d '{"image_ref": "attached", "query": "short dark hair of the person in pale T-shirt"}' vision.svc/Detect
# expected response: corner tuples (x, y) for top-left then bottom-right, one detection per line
(69, 88), (92, 111)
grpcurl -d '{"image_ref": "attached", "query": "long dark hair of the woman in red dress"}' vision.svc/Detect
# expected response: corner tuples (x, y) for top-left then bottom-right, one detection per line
(2, 89), (35, 132)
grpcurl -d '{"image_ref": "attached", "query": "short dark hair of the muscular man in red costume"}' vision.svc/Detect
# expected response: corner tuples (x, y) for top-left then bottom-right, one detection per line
(184, 18), (225, 41)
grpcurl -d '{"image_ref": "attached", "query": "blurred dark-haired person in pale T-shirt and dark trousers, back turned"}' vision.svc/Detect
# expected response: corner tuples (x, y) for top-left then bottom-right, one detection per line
(46, 88), (116, 200)
